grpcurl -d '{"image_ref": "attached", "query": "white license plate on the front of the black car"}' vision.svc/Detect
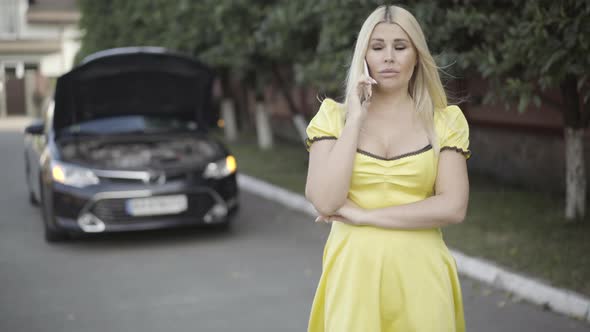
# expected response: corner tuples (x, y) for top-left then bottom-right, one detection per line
(125, 195), (188, 216)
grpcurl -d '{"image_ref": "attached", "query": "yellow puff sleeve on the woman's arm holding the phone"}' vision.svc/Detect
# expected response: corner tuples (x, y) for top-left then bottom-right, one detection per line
(305, 99), (341, 151)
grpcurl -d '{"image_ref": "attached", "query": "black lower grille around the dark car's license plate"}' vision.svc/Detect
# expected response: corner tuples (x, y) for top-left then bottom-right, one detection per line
(90, 193), (215, 224)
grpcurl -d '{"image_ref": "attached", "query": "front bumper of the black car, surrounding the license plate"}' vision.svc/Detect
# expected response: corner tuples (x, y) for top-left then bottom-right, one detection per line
(53, 175), (238, 233)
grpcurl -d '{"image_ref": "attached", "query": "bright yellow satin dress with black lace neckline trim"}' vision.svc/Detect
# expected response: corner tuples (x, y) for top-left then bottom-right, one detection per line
(307, 99), (470, 332)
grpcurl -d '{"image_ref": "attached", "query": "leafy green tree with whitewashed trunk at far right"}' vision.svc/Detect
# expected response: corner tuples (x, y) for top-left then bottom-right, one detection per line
(446, 0), (590, 221)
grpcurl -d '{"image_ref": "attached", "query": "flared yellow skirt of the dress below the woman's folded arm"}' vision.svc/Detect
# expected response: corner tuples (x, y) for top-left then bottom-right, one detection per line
(308, 222), (465, 332)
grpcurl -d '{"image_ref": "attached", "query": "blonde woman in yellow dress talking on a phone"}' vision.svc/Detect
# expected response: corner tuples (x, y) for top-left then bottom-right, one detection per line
(305, 6), (470, 332)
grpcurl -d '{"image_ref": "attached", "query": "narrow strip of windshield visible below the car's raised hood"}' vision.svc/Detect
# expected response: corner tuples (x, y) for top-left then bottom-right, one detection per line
(64, 115), (197, 135)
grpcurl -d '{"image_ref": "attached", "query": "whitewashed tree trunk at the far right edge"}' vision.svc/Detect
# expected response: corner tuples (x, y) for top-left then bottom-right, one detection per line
(565, 128), (586, 222)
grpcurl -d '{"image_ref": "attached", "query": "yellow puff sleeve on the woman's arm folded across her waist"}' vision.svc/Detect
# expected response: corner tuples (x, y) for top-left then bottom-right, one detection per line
(440, 105), (471, 159)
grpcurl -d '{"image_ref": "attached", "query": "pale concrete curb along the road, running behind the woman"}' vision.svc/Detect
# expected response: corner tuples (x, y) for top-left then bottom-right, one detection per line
(238, 174), (590, 322)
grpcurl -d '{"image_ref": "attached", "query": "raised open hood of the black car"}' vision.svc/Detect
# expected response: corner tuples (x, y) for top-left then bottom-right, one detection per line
(53, 47), (213, 132)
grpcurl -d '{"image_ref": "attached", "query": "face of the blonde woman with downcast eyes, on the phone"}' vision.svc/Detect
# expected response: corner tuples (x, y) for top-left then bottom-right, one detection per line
(365, 23), (417, 91)
